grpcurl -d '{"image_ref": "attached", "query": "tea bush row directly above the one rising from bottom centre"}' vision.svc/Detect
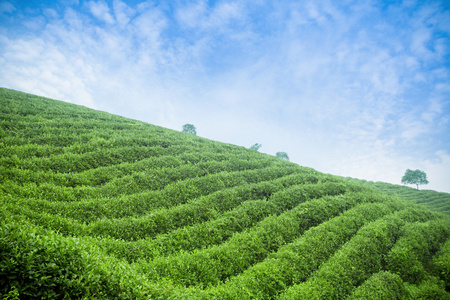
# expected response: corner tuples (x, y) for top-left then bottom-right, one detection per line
(142, 191), (380, 286)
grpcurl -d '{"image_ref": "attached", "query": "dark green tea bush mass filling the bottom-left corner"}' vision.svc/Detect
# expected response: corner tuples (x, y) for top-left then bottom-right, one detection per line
(0, 216), (174, 300)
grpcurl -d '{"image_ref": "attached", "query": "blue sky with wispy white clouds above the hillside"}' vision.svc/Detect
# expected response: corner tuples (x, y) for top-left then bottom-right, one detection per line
(0, 0), (450, 192)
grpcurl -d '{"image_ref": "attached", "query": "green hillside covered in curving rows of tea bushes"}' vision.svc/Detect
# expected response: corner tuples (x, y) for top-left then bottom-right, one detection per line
(0, 89), (450, 299)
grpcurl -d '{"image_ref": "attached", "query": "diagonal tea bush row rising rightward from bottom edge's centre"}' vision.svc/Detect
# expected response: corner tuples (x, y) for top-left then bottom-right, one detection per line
(205, 200), (405, 299)
